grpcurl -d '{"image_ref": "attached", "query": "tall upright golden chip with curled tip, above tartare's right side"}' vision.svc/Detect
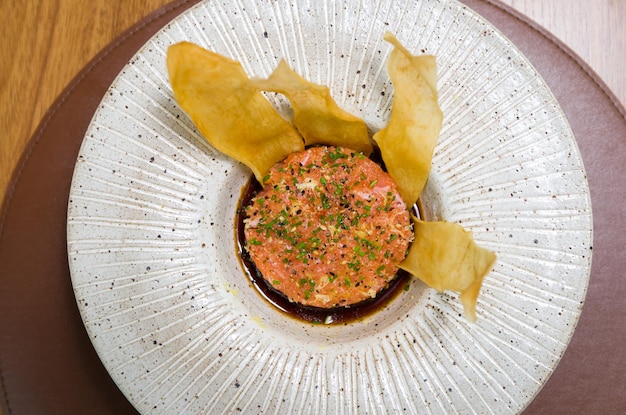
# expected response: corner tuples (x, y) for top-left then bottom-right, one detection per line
(374, 32), (443, 206)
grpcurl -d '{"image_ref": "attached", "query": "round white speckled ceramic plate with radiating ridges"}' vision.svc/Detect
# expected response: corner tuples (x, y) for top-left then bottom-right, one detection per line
(68, 0), (592, 414)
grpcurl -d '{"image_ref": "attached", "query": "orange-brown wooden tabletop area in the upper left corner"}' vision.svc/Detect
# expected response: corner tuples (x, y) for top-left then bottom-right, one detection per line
(0, 0), (169, 210)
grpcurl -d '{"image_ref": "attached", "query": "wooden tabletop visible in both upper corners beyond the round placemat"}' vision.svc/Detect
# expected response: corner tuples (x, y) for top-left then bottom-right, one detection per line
(0, 0), (626, 415)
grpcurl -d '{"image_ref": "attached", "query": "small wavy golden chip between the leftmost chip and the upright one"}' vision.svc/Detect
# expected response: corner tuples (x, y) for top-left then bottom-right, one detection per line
(251, 61), (372, 155)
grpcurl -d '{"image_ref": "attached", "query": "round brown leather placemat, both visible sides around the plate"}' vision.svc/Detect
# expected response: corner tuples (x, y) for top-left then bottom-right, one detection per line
(0, 0), (626, 415)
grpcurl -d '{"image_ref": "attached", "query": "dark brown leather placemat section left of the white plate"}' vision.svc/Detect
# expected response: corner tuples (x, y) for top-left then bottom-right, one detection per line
(0, 0), (197, 415)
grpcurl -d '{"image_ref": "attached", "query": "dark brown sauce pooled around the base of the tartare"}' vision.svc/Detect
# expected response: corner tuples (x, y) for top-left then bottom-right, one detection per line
(235, 149), (421, 324)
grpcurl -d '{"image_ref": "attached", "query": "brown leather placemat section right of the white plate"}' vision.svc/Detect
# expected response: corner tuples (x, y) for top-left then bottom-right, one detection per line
(464, 0), (626, 415)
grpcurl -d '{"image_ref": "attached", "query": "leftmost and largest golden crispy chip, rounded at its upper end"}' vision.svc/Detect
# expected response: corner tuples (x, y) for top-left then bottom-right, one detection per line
(167, 42), (304, 182)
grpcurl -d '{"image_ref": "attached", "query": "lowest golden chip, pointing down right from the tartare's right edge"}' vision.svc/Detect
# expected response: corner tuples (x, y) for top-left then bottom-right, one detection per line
(400, 218), (496, 321)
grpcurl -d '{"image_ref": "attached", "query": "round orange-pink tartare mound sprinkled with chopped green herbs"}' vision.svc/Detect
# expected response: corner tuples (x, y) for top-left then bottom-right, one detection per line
(244, 146), (413, 308)
